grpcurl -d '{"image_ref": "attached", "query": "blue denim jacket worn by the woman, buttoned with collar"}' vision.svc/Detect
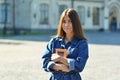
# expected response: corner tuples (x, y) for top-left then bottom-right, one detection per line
(42, 37), (88, 80)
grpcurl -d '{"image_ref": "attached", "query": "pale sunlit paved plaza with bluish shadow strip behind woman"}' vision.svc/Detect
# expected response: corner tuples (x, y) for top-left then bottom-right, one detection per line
(0, 31), (120, 80)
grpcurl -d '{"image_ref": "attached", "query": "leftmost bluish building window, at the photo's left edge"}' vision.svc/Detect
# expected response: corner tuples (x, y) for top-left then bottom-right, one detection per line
(0, 3), (10, 23)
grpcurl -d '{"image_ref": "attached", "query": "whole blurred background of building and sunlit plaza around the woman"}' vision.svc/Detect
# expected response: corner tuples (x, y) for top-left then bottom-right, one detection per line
(0, 0), (120, 80)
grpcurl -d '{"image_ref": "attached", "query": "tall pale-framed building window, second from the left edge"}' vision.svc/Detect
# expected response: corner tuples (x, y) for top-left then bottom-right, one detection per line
(40, 4), (49, 24)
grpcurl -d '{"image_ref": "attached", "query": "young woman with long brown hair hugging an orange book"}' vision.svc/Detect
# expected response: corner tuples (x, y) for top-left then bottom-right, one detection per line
(42, 8), (88, 80)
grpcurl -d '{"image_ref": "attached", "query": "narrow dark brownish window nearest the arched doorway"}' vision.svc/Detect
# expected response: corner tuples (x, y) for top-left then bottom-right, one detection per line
(93, 7), (100, 25)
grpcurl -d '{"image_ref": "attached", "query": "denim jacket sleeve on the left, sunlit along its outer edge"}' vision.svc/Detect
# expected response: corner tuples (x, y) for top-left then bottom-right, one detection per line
(42, 38), (55, 72)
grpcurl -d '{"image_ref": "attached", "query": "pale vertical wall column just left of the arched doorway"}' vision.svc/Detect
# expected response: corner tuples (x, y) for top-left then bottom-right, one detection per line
(104, 0), (109, 30)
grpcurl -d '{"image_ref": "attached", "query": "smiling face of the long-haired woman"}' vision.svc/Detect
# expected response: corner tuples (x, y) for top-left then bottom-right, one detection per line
(62, 15), (73, 34)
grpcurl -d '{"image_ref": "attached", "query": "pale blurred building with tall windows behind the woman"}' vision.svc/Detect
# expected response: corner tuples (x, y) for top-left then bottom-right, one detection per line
(0, 0), (120, 31)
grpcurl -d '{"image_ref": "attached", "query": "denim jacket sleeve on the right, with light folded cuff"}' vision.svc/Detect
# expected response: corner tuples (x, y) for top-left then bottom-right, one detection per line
(68, 40), (88, 72)
